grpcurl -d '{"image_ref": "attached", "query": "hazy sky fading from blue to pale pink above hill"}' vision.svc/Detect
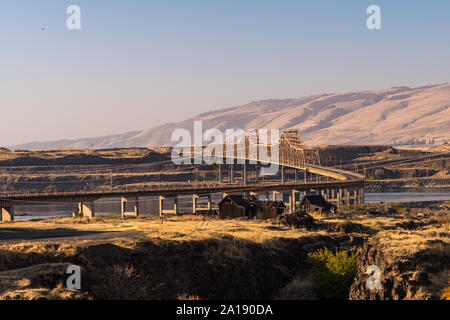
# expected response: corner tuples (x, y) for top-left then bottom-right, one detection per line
(0, 0), (450, 145)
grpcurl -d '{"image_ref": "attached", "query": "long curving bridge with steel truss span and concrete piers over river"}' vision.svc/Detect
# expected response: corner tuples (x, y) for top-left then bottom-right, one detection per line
(0, 131), (364, 221)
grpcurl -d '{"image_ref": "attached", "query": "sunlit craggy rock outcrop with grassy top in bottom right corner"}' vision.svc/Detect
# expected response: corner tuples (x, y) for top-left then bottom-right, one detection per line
(349, 224), (450, 300)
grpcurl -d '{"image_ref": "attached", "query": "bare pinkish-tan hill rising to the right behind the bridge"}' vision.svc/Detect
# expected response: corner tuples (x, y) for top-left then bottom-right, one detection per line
(11, 84), (450, 150)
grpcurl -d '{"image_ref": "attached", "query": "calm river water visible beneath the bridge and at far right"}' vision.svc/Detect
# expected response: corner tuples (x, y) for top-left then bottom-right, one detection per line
(15, 192), (450, 220)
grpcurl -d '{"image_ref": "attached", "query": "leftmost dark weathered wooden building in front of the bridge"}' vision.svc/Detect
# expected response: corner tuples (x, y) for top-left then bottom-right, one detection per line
(219, 195), (258, 219)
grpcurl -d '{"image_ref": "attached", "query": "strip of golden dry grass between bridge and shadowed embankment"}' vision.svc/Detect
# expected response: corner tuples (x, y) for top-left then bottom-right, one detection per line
(0, 215), (324, 243)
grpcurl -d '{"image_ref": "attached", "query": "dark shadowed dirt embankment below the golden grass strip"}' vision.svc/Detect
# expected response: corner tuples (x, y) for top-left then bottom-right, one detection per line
(0, 235), (362, 299)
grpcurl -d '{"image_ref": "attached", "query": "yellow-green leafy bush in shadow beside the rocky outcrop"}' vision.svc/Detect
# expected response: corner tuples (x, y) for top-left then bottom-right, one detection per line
(308, 248), (358, 300)
